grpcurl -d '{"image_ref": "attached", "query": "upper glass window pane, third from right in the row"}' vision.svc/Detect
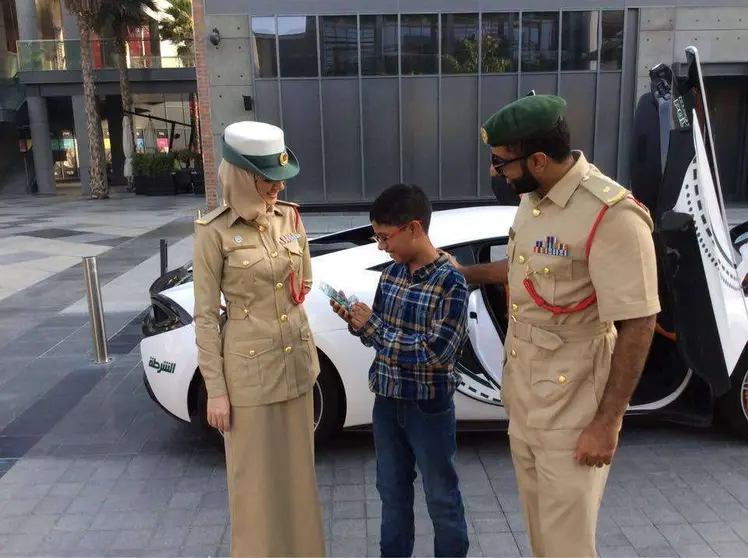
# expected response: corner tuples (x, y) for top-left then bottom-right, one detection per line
(522, 12), (559, 72)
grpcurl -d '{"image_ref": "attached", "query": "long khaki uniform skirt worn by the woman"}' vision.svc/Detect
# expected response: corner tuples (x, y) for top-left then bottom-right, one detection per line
(226, 390), (326, 558)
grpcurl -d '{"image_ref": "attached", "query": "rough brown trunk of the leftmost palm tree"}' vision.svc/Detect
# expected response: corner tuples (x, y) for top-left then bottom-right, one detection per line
(77, 15), (109, 199)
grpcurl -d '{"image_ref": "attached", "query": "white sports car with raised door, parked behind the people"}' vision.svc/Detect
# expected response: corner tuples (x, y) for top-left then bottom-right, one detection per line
(140, 49), (748, 450)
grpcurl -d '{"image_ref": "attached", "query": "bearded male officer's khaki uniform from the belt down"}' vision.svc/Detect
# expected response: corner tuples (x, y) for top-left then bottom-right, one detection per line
(502, 322), (616, 558)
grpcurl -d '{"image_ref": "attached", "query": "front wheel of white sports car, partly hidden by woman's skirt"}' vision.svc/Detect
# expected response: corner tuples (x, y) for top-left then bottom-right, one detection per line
(197, 357), (343, 449)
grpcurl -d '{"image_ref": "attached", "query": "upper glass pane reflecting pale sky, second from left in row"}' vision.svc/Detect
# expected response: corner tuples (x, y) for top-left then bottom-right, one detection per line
(278, 16), (318, 77)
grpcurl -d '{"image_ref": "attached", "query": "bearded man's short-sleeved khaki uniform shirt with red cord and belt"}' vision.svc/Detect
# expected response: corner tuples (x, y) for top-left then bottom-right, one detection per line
(502, 152), (660, 449)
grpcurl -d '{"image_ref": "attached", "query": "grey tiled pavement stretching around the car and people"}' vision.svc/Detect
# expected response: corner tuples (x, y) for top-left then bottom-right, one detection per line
(0, 195), (748, 556)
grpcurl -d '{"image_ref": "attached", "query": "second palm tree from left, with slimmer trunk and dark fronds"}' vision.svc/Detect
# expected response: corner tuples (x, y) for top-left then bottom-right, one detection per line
(96, 0), (158, 191)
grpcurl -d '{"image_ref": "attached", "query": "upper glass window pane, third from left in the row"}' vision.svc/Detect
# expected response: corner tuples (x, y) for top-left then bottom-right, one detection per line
(319, 16), (358, 76)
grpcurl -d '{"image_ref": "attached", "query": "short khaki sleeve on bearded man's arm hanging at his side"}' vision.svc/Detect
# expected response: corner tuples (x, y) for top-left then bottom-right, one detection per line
(589, 199), (660, 322)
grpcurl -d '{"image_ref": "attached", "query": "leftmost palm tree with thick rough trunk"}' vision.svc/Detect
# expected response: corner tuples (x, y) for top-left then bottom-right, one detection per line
(65, 0), (109, 199)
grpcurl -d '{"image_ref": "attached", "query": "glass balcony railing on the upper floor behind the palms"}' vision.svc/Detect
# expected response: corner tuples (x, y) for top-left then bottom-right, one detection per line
(17, 39), (195, 72)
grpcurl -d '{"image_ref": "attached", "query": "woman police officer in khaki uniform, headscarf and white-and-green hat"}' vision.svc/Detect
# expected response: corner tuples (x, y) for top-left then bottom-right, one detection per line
(193, 122), (325, 557)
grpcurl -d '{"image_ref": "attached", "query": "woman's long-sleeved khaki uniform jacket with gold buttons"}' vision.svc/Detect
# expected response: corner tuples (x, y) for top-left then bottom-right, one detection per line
(192, 202), (319, 407)
